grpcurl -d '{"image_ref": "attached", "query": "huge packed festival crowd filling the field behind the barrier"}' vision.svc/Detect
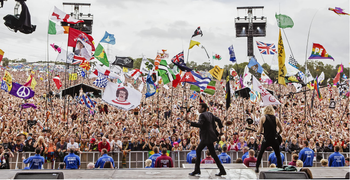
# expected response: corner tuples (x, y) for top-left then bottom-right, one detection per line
(0, 67), (350, 169)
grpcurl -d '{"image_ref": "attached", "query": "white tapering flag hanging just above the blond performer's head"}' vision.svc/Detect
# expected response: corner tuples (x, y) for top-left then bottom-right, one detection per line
(252, 76), (281, 106)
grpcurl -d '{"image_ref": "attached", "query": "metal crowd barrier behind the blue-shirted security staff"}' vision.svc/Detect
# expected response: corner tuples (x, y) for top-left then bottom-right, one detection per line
(9, 151), (350, 169)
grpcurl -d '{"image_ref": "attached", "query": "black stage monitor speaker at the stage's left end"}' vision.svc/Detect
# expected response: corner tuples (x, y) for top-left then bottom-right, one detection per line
(13, 172), (64, 179)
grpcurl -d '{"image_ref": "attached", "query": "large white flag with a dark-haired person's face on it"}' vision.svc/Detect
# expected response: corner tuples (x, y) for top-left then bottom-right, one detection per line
(102, 82), (142, 111)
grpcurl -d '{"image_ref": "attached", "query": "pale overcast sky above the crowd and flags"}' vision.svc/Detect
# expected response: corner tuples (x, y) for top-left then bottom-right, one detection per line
(0, 0), (350, 67)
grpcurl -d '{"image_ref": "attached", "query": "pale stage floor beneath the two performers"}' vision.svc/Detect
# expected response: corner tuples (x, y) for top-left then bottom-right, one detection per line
(0, 164), (349, 179)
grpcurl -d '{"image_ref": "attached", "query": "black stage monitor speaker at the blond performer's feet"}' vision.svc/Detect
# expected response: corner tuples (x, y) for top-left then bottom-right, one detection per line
(259, 171), (309, 179)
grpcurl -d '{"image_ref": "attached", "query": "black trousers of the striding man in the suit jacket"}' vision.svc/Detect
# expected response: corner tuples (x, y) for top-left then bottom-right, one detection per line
(194, 141), (226, 173)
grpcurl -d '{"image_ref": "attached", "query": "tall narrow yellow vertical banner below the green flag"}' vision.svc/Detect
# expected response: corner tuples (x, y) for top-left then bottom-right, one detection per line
(278, 29), (287, 86)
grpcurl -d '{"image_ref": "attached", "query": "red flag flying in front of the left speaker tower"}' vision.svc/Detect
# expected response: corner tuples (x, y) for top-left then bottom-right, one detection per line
(68, 28), (95, 51)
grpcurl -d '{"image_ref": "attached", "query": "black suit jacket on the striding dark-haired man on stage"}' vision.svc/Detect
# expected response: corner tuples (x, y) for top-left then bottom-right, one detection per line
(191, 111), (223, 144)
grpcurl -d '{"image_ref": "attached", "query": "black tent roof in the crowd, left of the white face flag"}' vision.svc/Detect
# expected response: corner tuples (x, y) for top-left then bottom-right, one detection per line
(62, 83), (102, 98)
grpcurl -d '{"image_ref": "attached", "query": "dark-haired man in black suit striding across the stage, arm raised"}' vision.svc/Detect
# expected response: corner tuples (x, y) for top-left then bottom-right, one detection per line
(186, 103), (226, 176)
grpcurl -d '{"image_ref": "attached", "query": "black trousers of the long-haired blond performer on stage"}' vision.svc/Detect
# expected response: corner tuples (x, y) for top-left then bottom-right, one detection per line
(256, 138), (282, 168)
